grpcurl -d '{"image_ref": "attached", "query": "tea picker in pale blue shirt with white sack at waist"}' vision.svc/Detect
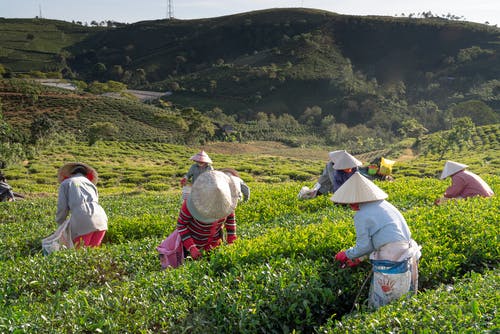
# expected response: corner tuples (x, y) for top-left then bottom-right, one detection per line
(331, 172), (421, 308)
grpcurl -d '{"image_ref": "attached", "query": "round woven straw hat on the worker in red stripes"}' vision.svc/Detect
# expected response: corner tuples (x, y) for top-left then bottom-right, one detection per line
(186, 170), (239, 223)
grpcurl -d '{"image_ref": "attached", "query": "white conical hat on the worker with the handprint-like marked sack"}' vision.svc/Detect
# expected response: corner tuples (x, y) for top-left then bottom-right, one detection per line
(330, 172), (388, 204)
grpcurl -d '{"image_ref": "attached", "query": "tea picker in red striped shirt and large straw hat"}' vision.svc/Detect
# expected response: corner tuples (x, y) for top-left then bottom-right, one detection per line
(177, 170), (240, 259)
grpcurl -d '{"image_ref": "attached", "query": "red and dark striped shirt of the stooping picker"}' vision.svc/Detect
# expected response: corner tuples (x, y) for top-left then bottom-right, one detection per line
(177, 201), (236, 250)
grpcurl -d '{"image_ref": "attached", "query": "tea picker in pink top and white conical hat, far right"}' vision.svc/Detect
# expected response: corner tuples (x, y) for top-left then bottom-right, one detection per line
(435, 160), (494, 205)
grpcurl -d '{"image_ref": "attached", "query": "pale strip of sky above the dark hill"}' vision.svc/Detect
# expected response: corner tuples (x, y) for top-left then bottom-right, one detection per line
(0, 0), (500, 26)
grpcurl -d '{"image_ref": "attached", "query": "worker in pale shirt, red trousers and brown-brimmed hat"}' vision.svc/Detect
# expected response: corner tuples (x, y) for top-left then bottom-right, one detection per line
(56, 162), (108, 247)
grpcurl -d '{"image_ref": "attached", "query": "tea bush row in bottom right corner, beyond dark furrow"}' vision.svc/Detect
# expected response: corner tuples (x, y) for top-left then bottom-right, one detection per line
(318, 269), (500, 334)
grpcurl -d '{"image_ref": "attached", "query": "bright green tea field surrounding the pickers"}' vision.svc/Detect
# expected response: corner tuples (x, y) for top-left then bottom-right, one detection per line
(0, 141), (500, 333)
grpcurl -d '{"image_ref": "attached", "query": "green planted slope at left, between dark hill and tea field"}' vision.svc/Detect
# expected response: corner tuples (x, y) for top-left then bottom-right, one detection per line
(0, 80), (191, 143)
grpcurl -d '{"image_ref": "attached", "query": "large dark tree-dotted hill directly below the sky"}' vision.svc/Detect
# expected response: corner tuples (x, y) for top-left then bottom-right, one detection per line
(0, 9), (500, 146)
